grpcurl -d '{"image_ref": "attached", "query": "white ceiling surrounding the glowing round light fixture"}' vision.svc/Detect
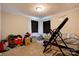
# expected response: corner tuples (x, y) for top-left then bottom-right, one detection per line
(2, 3), (79, 17)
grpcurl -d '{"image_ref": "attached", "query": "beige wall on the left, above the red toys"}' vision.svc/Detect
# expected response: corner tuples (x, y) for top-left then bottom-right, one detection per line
(2, 13), (29, 38)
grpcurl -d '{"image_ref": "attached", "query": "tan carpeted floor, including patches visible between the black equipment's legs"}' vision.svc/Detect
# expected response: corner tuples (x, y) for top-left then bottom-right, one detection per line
(2, 40), (77, 56)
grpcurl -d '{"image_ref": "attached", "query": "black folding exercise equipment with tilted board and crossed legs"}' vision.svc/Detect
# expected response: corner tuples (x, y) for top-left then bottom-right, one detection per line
(43, 17), (79, 56)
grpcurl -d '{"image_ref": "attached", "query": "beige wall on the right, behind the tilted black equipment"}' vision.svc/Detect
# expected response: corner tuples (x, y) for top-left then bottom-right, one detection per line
(51, 8), (79, 35)
